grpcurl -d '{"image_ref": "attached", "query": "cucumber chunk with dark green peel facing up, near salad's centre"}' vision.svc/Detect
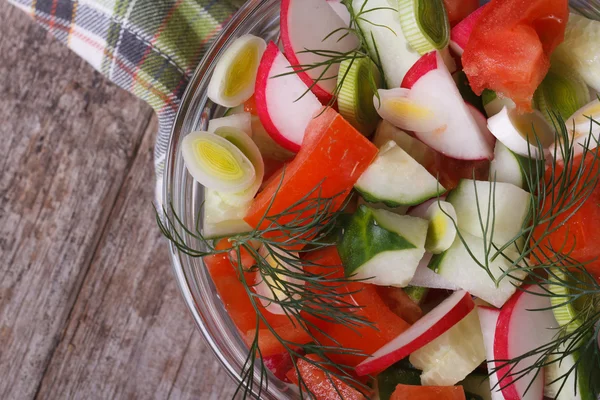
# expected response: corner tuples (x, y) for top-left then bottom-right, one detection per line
(338, 205), (427, 287)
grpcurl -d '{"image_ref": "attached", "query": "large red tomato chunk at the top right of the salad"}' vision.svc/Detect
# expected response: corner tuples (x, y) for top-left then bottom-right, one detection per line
(462, 0), (569, 112)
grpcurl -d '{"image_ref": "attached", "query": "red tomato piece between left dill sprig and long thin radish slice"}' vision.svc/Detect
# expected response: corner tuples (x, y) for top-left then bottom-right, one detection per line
(305, 246), (410, 366)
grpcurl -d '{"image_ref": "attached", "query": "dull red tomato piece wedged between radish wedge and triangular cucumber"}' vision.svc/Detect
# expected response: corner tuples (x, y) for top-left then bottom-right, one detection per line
(373, 120), (436, 166)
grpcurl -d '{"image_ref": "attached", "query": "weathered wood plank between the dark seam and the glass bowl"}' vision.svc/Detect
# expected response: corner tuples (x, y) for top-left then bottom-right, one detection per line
(38, 119), (234, 399)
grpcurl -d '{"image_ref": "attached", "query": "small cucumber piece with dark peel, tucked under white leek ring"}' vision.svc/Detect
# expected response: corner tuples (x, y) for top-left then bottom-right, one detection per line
(490, 141), (546, 190)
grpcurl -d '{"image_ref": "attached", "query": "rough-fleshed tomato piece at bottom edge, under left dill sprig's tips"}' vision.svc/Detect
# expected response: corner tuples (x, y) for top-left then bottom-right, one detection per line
(287, 354), (365, 400)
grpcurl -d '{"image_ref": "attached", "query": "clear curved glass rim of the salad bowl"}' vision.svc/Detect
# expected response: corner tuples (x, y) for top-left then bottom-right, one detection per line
(161, 0), (272, 397)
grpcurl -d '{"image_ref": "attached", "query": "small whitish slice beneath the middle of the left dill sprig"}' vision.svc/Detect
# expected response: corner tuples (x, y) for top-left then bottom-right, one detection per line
(254, 246), (304, 315)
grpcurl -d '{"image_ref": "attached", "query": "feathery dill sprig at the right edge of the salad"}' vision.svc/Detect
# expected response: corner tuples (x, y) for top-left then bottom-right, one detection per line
(442, 111), (600, 396)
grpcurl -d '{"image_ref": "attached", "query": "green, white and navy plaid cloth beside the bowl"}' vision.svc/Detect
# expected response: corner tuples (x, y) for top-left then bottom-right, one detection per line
(9, 0), (244, 202)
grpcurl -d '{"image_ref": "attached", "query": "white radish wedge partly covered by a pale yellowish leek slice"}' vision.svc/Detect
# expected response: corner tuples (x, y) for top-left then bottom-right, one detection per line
(410, 52), (494, 160)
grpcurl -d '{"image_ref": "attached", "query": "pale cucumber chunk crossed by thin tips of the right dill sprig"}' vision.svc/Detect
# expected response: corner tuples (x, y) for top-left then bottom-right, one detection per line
(446, 179), (532, 246)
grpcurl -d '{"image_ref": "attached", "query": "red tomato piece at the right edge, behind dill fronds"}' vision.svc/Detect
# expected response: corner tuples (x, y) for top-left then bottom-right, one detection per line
(533, 153), (600, 281)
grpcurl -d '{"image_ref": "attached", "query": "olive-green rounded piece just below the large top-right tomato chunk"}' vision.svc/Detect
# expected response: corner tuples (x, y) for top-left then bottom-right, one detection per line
(533, 60), (591, 121)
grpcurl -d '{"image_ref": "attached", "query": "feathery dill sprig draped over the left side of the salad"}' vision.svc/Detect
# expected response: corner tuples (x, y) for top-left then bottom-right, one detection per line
(156, 176), (375, 398)
